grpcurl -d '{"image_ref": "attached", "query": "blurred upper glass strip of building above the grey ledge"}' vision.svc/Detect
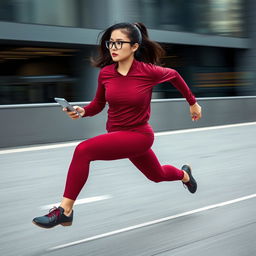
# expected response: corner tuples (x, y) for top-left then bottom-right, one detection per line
(0, 0), (246, 37)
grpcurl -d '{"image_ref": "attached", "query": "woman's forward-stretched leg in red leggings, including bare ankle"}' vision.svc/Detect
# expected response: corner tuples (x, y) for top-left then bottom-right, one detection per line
(62, 131), (153, 202)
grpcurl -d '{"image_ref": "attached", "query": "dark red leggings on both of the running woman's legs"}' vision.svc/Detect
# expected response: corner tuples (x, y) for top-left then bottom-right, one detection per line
(63, 126), (184, 200)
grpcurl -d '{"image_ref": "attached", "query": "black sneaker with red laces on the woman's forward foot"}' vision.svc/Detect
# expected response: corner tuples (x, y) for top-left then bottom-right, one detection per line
(33, 207), (73, 228)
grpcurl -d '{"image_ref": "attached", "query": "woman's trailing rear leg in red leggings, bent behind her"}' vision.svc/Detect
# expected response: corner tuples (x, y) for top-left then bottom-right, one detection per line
(130, 149), (185, 182)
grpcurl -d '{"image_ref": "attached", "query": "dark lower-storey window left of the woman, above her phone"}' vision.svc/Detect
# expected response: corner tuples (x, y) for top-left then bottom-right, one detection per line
(0, 45), (80, 104)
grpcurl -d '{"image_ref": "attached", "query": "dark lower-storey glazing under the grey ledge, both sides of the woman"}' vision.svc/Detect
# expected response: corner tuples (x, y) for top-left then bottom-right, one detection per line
(0, 44), (252, 105)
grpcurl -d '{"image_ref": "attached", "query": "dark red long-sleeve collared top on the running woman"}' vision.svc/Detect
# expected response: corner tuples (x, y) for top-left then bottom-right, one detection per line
(84, 60), (196, 132)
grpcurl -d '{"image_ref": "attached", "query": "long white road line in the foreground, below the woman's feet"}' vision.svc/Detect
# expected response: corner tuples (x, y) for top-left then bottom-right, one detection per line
(47, 194), (256, 251)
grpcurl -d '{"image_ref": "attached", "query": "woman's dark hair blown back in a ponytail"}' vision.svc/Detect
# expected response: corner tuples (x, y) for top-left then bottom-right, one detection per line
(91, 22), (165, 68)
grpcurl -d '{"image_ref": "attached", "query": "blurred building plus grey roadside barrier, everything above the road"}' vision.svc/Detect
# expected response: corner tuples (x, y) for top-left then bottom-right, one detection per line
(0, 0), (256, 147)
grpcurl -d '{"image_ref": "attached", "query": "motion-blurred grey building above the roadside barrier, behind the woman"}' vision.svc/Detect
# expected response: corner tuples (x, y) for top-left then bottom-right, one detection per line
(0, 0), (256, 104)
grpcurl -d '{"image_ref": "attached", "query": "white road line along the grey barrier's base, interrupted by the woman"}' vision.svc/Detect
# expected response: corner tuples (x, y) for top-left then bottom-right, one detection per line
(0, 122), (256, 155)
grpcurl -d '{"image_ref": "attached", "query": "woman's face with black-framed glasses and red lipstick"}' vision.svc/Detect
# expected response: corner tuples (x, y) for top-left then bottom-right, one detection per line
(109, 29), (139, 62)
